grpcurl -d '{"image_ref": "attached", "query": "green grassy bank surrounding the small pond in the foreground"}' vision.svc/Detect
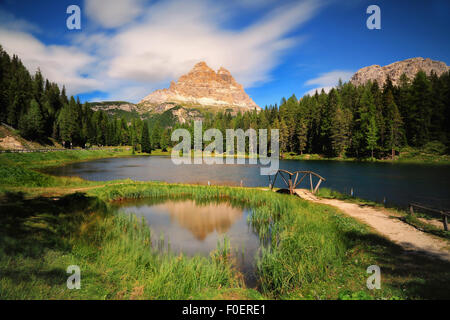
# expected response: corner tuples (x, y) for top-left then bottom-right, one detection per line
(0, 150), (450, 299)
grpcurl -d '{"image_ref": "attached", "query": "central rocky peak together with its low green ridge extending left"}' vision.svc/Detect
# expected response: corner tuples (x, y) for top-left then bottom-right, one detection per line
(89, 62), (261, 123)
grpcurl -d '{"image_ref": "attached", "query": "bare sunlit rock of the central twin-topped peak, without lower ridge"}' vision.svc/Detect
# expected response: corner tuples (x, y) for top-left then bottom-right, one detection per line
(138, 61), (261, 112)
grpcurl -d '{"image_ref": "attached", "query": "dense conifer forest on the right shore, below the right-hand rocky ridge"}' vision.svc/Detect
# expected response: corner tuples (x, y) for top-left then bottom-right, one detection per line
(178, 71), (450, 158)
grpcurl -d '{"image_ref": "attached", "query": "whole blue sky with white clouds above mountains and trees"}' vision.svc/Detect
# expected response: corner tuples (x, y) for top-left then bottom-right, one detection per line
(0, 0), (450, 107)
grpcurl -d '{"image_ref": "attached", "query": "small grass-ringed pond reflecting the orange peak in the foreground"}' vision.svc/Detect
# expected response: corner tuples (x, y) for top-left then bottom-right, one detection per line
(117, 199), (260, 287)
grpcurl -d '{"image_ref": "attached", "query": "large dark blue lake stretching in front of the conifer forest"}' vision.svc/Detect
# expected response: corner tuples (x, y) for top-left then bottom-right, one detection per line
(46, 156), (450, 209)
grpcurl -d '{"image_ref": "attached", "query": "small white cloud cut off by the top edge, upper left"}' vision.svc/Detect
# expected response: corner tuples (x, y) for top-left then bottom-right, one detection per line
(84, 0), (144, 28)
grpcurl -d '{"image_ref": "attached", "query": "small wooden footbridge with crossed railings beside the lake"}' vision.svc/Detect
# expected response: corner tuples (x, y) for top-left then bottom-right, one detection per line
(270, 169), (326, 196)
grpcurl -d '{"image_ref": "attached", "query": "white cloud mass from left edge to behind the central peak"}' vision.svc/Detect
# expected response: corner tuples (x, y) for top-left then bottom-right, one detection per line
(0, 0), (322, 102)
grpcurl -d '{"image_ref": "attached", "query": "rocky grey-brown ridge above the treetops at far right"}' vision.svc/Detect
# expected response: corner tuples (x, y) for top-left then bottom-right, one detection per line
(350, 58), (450, 86)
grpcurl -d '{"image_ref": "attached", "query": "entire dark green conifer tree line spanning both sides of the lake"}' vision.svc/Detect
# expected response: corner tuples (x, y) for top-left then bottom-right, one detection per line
(0, 47), (450, 158)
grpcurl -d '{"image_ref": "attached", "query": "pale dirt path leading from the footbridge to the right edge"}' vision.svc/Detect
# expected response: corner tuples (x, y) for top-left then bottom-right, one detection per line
(296, 189), (450, 261)
